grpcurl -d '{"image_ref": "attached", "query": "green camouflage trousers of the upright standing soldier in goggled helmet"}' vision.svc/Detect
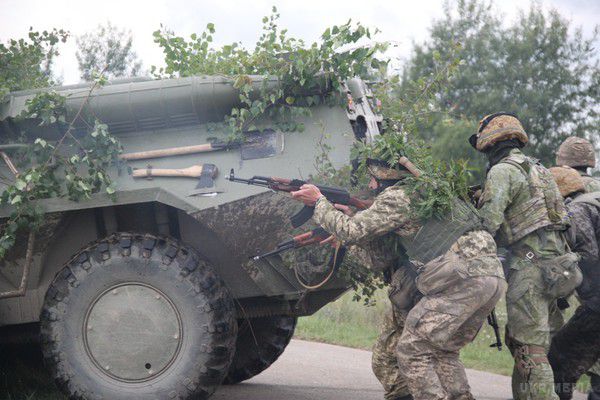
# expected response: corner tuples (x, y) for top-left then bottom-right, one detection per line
(506, 257), (564, 400)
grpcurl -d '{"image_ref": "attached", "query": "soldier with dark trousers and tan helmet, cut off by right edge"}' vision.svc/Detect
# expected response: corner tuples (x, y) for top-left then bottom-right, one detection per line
(548, 167), (600, 400)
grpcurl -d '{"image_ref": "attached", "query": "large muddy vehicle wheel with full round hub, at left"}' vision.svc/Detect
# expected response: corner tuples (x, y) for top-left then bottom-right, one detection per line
(41, 233), (237, 400)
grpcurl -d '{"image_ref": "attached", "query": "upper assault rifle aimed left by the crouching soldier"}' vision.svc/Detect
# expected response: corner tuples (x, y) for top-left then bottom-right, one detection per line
(226, 169), (372, 228)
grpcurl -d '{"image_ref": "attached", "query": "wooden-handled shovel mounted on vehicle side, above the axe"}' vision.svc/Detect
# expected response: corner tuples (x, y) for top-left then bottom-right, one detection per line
(119, 129), (283, 161)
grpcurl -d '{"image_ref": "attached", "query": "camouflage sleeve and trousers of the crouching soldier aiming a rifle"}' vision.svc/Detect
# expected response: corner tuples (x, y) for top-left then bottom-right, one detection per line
(314, 184), (506, 399)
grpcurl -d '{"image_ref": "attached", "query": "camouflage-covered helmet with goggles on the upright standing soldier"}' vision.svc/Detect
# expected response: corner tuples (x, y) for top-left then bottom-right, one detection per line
(469, 112), (529, 153)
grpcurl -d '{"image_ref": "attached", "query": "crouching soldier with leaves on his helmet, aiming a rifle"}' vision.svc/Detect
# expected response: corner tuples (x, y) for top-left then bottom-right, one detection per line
(292, 155), (506, 400)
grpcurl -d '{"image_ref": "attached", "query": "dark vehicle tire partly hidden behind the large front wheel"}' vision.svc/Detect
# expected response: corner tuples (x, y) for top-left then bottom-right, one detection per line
(223, 316), (297, 385)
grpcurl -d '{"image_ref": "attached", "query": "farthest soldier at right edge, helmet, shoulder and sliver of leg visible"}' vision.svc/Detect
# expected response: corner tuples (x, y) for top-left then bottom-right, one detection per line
(556, 136), (600, 399)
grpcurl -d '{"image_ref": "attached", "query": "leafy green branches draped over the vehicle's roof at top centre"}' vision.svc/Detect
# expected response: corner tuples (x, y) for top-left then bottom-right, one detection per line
(151, 7), (387, 140)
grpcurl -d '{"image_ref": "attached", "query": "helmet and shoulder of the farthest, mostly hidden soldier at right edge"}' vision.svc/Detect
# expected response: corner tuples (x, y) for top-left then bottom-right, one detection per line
(556, 136), (600, 193)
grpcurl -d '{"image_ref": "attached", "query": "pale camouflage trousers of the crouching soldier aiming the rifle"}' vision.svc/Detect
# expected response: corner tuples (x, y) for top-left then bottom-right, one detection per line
(398, 276), (506, 400)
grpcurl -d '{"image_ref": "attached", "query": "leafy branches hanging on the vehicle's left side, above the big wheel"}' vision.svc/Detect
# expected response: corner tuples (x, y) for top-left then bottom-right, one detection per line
(0, 75), (121, 259)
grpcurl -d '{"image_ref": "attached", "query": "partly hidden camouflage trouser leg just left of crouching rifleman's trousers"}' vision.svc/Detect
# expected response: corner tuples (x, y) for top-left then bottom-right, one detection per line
(371, 306), (410, 400)
